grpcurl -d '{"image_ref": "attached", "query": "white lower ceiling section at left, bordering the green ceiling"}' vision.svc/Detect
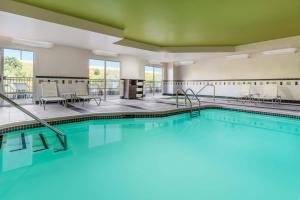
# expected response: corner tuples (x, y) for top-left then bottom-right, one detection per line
(0, 12), (228, 62)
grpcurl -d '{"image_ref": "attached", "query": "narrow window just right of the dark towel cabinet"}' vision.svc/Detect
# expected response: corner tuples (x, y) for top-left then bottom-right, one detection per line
(145, 66), (163, 96)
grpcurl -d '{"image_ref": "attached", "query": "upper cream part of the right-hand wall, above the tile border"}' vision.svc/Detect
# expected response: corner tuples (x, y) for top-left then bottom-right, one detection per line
(178, 36), (300, 80)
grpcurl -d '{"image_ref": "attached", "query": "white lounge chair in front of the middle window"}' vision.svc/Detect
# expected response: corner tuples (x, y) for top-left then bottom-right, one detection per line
(75, 83), (102, 106)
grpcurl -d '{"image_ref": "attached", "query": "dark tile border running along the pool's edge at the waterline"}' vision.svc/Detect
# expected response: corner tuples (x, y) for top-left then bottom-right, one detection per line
(0, 105), (300, 135)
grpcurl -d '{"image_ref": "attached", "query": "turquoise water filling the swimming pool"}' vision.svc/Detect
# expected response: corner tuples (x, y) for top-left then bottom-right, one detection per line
(0, 110), (300, 200)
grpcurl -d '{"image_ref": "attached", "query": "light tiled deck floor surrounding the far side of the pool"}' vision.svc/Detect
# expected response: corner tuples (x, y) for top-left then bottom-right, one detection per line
(0, 97), (300, 132)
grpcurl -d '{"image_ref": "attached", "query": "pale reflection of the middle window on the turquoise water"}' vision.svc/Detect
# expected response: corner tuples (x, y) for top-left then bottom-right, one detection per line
(89, 124), (122, 148)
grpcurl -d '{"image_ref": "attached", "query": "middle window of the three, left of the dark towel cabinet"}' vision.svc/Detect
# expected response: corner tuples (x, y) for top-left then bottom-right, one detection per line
(89, 59), (121, 99)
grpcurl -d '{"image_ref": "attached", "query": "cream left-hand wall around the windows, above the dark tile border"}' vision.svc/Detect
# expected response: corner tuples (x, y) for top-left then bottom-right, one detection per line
(0, 37), (147, 79)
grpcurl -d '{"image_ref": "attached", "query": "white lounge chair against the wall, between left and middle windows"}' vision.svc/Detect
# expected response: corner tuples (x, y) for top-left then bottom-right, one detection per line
(40, 82), (67, 110)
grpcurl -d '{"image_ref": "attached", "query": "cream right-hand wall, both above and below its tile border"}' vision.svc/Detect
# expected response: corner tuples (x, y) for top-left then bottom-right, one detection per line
(164, 36), (300, 101)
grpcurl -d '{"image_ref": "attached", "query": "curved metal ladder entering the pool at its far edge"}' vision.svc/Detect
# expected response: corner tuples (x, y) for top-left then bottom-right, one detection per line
(176, 88), (200, 117)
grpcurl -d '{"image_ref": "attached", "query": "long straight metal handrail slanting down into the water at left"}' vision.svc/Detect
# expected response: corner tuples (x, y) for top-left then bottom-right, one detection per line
(0, 92), (68, 150)
